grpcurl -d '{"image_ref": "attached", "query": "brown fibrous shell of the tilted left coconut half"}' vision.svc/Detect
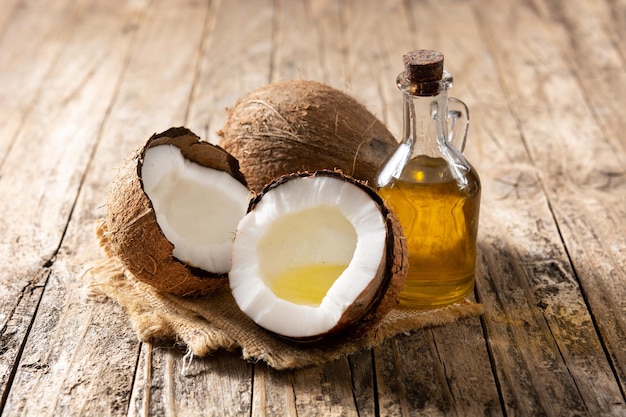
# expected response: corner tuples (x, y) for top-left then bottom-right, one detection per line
(98, 128), (246, 295)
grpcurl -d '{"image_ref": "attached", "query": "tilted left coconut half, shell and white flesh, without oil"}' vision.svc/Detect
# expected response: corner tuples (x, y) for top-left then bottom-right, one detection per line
(99, 128), (250, 295)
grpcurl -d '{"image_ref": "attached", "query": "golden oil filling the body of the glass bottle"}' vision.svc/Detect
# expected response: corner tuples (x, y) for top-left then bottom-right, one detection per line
(379, 156), (480, 308)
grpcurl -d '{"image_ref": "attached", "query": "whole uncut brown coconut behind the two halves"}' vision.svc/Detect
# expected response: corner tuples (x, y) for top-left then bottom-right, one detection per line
(218, 80), (398, 192)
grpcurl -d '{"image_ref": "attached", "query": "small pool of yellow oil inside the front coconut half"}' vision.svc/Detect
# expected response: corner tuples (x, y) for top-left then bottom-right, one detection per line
(268, 264), (348, 306)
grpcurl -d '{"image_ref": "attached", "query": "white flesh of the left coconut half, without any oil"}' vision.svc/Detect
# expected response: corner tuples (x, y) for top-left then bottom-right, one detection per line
(141, 145), (249, 273)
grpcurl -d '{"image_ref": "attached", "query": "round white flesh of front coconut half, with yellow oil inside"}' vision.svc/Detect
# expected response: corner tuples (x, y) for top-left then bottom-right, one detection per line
(229, 176), (386, 338)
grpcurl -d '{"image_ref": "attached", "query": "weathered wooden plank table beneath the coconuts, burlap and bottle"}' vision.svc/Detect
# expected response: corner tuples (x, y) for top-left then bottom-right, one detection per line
(0, 0), (626, 416)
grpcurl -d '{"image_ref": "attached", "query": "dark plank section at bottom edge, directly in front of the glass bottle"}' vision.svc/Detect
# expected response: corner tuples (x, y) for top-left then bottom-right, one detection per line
(374, 312), (503, 416)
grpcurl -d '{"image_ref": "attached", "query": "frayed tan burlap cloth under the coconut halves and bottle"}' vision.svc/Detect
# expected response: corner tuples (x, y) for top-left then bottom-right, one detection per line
(83, 252), (482, 369)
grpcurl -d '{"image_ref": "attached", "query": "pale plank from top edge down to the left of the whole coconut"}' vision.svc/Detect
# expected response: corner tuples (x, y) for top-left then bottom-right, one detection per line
(186, 0), (274, 143)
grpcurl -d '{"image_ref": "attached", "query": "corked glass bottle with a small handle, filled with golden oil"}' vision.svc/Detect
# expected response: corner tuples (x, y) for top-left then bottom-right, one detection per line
(376, 50), (481, 308)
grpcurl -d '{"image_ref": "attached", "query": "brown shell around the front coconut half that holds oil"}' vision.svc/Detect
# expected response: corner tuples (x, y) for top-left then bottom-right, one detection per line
(241, 170), (409, 343)
